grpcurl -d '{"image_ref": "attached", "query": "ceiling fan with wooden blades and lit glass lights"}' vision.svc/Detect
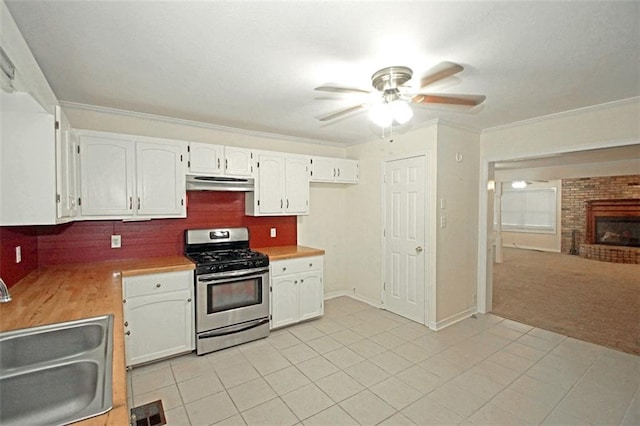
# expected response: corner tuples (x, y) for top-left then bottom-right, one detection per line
(315, 62), (486, 127)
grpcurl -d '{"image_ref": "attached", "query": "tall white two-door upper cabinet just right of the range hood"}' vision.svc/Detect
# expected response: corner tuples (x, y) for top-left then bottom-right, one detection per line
(245, 152), (309, 216)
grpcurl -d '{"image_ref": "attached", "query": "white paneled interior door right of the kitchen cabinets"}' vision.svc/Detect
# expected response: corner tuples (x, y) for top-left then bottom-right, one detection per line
(384, 156), (426, 324)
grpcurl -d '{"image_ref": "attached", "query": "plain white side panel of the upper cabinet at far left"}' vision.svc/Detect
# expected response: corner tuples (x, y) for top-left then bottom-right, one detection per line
(0, 91), (58, 225)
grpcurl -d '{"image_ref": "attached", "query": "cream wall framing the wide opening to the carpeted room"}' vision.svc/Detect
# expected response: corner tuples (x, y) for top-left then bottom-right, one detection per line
(478, 98), (640, 312)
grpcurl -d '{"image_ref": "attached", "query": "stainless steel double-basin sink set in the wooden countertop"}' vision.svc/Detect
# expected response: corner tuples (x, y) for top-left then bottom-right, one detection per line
(0, 315), (113, 426)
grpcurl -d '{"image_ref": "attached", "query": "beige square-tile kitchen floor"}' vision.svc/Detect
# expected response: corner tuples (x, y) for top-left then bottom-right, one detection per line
(131, 297), (640, 426)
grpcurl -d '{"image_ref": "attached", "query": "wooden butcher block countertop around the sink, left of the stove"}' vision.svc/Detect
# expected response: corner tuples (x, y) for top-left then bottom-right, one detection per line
(0, 256), (195, 426)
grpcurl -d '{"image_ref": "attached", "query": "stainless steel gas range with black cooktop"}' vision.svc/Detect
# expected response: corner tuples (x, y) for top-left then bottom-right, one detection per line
(185, 228), (269, 355)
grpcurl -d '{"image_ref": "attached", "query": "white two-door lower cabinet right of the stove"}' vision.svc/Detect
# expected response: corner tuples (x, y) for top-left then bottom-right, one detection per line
(270, 256), (324, 329)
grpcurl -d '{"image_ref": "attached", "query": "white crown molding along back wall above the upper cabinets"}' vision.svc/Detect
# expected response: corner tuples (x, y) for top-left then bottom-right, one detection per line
(59, 101), (348, 148)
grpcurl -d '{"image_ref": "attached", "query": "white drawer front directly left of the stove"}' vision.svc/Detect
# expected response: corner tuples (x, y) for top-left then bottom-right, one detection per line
(122, 271), (193, 297)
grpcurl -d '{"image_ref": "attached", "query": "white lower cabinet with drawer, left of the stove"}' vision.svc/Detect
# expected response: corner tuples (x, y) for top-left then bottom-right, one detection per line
(122, 271), (195, 366)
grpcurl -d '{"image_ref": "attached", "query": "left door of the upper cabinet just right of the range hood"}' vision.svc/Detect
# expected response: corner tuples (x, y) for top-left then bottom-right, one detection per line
(257, 154), (284, 215)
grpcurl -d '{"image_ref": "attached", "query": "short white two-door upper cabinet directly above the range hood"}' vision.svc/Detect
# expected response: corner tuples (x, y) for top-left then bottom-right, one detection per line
(189, 142), (253, 176)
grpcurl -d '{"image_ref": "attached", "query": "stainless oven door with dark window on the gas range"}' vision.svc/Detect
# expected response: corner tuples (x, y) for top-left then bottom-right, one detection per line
(196, 267), (269, 333)
